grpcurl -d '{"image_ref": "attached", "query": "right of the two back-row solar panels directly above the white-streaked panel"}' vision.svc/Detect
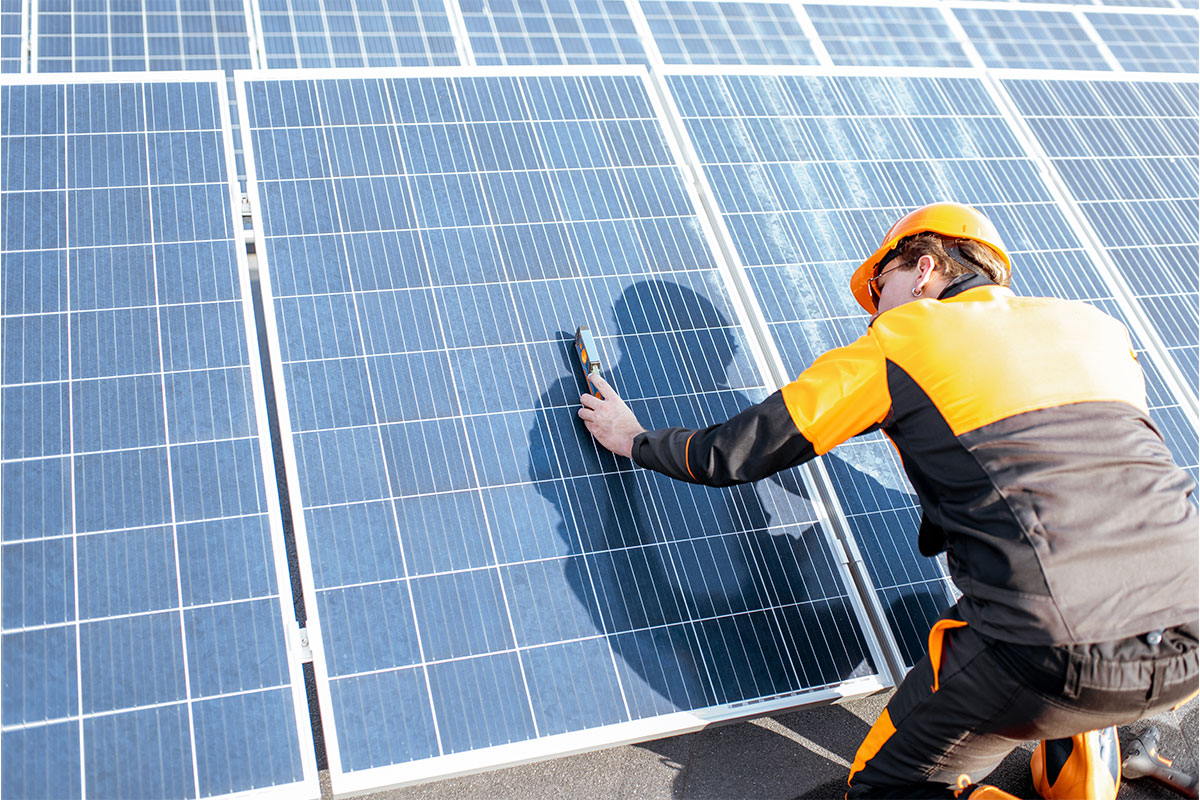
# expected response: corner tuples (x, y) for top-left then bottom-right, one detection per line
(804, 5), (971, 67)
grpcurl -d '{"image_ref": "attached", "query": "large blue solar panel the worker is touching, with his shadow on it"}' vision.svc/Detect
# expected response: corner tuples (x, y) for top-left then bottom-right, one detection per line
(246, 73), (875, 790)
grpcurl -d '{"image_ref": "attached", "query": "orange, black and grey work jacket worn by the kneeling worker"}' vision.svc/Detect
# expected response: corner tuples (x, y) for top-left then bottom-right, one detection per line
(632, 276), (1200, 644)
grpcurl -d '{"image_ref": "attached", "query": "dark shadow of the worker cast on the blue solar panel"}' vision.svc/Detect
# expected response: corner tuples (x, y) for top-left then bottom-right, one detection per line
(529, 281), (875, 791)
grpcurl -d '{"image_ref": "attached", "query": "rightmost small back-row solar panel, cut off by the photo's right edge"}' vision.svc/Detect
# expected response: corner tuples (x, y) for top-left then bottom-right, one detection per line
(1085, 12), (1200, 73)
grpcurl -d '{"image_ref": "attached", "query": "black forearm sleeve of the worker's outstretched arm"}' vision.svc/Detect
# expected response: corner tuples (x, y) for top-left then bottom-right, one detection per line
(632, 392), (816, 486)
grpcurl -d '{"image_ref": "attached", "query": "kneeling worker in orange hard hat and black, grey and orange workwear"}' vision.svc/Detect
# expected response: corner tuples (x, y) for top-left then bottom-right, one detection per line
(578, 203), (1200, 798)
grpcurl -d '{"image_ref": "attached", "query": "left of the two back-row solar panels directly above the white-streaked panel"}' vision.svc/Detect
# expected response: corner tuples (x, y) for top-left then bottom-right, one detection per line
(641, 0), (817, 64)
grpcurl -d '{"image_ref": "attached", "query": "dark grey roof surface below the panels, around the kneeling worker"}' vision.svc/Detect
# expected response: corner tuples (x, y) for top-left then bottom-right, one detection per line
(323, 693), (1198, 800)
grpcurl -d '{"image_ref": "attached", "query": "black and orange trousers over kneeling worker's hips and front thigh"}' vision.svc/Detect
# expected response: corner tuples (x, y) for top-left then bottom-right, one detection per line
(850, 609), (1196, 798)
